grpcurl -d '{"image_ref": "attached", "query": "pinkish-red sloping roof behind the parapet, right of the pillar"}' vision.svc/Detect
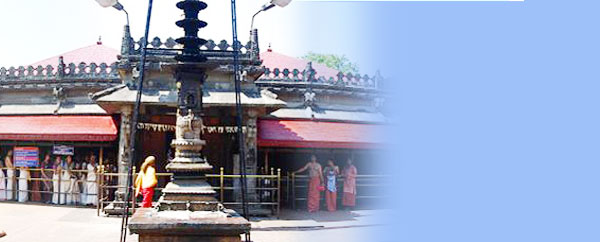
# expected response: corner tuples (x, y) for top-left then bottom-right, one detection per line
(260, 51), (339, 79)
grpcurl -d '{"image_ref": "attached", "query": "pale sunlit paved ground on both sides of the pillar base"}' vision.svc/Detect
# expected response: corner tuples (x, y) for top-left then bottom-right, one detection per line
(0, 203), (378, 242)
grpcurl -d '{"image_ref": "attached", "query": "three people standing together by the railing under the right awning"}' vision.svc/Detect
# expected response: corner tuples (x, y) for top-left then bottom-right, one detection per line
(294, 155), (358, 212)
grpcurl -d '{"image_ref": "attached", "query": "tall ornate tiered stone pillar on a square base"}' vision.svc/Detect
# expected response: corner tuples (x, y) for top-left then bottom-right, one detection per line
(129, 0), (250, 242)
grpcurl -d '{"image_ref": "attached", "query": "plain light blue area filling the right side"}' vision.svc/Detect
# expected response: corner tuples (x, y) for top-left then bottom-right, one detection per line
(296, 0), (600, 242)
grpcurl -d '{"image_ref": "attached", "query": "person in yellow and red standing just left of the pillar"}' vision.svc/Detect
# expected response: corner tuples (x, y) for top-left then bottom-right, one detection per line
(135, 156), (158, 208)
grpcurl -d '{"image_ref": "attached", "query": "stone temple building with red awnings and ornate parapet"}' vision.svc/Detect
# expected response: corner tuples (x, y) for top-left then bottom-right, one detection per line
(0, 29), (386, 213)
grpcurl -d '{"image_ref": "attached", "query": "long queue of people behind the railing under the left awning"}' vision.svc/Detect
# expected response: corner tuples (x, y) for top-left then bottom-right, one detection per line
(0, 150), (98, 205)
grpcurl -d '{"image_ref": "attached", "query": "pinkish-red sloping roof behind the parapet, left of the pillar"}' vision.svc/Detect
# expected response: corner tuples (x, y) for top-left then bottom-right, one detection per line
(31, 44), (120, 68)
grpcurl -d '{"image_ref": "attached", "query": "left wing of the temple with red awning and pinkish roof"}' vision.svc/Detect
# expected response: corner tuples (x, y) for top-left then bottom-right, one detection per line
(0, 42), (121, 162)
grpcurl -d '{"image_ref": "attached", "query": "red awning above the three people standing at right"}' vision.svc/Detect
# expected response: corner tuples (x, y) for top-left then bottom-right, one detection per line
(258, 120), (379, 149)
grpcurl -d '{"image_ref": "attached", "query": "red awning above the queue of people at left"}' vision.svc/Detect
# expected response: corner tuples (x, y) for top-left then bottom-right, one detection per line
(0, 116), (117, 141)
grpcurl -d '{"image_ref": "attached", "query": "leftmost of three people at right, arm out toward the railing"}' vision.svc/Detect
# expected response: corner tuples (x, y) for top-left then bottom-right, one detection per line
(294, 155), (323, 213)
